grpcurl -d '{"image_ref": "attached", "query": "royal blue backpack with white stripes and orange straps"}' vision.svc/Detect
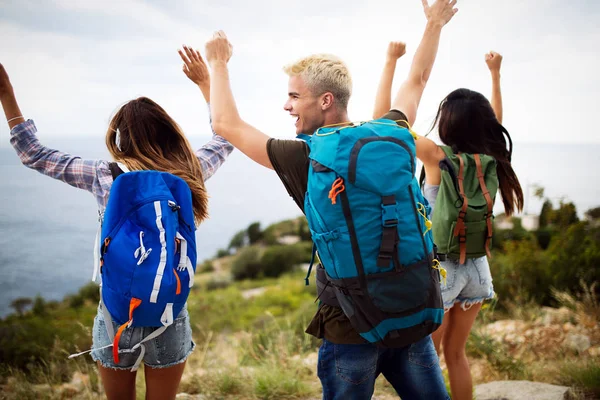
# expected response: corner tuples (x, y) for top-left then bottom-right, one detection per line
(88, 163), (196, 371)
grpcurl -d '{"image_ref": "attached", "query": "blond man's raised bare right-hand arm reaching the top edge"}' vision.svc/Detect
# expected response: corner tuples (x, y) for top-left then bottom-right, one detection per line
(392, 0), (458, 125)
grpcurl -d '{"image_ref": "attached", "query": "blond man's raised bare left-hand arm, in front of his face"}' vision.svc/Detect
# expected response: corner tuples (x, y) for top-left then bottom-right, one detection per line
(206, 31), (273, 169)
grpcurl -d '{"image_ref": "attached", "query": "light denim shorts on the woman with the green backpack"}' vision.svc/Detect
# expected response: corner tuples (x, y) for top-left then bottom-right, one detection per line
(440, 256), (494, 310)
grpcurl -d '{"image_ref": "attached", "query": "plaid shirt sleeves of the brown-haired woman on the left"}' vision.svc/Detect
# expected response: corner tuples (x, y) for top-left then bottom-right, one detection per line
(10, 115), (233, 213)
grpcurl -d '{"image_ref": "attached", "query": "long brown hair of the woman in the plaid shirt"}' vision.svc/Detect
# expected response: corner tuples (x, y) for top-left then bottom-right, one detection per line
(106, 97), (208, 224)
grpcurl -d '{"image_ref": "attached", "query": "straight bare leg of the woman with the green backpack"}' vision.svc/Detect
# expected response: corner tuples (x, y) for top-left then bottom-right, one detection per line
(442, 304), (481, 400)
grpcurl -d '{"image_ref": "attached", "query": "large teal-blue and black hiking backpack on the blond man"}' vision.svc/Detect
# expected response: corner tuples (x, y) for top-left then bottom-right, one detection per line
(299, 119), (444, 347)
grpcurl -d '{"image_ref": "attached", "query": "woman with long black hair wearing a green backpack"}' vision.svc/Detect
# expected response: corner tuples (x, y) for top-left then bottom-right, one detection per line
(373, 47), (523, 400)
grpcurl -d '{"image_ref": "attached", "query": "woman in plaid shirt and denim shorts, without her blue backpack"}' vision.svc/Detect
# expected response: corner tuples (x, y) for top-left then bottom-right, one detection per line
(0, 47), (233, 400)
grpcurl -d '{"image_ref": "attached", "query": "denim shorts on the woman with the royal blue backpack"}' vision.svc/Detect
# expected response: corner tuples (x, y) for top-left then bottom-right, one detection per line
(91, 305), (196, 369)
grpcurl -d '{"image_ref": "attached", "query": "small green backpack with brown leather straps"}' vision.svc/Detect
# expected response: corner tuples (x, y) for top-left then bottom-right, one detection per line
(432, 146), (498, 264)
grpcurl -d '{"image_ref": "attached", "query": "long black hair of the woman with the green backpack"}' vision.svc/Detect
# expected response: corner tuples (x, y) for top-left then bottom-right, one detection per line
(432, 89), (523, 215)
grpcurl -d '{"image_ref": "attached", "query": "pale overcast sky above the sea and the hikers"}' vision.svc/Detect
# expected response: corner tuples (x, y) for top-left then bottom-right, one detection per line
(0, 0), (600, 146)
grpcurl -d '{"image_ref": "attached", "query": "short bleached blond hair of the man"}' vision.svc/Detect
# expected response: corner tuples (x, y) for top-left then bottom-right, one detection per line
(283, 54), (352, 110)
